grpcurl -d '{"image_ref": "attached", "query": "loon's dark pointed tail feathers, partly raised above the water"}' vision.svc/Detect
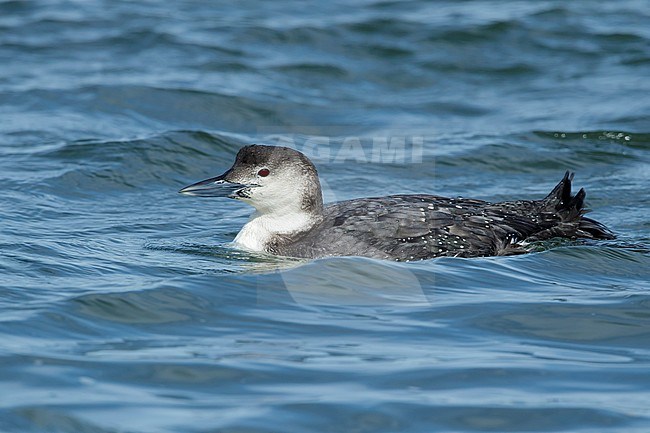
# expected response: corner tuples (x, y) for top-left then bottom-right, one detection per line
(543, 171), (616, 239)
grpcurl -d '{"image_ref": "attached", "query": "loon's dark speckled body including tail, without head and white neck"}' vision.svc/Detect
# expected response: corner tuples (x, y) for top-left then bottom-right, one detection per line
(275, 173), (613, 261)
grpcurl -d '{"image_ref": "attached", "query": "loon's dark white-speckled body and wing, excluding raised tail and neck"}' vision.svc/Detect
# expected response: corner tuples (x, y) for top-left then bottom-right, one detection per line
(278, 195), (535, 260)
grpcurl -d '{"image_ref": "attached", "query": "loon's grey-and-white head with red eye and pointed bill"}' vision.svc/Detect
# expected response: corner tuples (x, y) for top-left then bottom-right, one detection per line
(179, 144), (323, 214)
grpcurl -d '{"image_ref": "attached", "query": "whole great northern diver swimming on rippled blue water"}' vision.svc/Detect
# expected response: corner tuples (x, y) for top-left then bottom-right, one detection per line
(179, 145), (614, 261)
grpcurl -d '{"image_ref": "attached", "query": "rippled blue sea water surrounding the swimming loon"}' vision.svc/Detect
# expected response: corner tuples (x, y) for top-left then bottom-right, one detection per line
(0, 0), (650, 433)
